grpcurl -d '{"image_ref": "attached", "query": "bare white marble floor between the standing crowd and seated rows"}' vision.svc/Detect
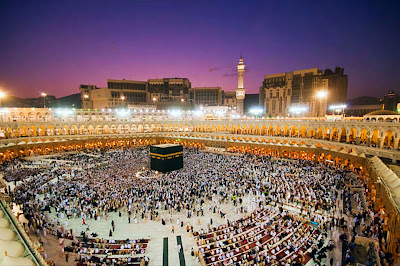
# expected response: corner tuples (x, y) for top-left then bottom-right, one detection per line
(44, 196), (255, 266)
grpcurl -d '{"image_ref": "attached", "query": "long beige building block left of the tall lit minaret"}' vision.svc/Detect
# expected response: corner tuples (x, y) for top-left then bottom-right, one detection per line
(79, 78), (237, 110)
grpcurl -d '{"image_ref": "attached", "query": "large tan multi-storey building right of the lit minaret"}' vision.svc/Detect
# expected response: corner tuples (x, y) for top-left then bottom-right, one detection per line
(259, 67), (347, 117)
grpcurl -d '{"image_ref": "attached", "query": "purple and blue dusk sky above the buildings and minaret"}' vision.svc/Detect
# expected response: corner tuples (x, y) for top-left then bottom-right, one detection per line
(0, 0), (400, 98)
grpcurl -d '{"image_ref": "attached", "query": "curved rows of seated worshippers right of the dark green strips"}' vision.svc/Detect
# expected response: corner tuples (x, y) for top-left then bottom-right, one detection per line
(194, 205), (330, 265)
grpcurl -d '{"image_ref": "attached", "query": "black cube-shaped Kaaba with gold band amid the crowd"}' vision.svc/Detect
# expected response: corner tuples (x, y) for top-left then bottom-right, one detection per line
(150, 144), (183, 173)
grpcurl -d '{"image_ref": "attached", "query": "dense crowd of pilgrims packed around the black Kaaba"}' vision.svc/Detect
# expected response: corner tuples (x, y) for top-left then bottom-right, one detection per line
(7, 148), (354, 264)
